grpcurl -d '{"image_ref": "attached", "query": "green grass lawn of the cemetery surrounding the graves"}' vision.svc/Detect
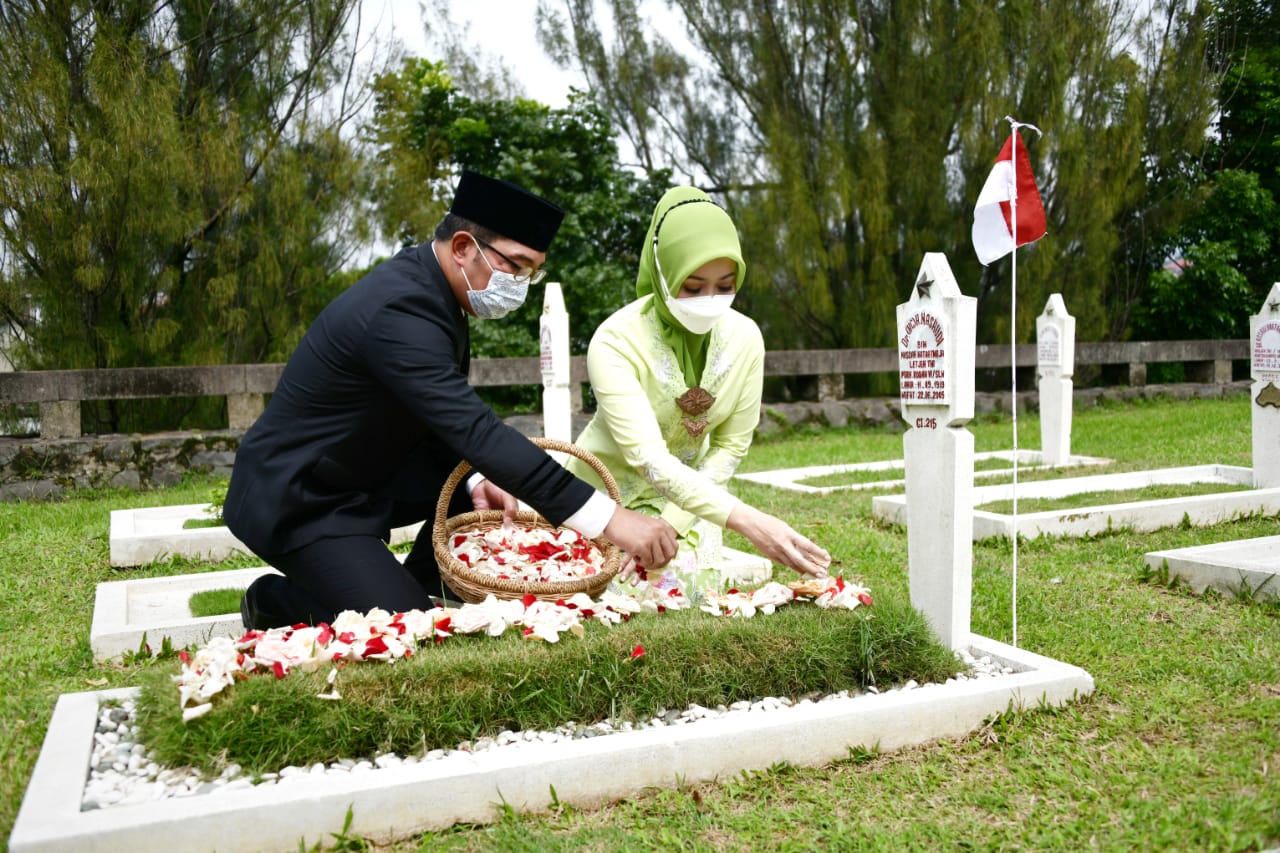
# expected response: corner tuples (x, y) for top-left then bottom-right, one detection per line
(0, 396), (1280, 852)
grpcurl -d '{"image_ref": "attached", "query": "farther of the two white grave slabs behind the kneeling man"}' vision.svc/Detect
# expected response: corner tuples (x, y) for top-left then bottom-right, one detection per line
(109, 503), (422, 567)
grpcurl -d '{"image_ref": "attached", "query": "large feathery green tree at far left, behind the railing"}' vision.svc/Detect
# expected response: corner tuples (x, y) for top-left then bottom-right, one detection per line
(0, 0), (366, 429)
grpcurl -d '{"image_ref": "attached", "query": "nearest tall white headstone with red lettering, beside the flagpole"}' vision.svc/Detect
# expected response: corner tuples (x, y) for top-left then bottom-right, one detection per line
(897, 252), (978, 649)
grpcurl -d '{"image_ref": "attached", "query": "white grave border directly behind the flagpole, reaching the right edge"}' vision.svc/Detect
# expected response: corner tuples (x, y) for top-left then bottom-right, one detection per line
(872, 465), (1280, 539)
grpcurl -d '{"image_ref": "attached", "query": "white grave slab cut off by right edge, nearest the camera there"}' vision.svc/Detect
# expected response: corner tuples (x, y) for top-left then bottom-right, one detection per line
(1146, 537), (1280, 599)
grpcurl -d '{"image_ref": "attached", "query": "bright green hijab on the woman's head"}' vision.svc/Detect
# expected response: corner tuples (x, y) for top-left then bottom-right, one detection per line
(636, 187), (746, 388)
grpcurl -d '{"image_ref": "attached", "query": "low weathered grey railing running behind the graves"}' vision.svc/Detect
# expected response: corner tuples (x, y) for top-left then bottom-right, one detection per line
(0, 339), (1249, 438)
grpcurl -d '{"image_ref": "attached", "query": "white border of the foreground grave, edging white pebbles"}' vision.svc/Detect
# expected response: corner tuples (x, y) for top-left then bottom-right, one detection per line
(9, 637), (1093, 853)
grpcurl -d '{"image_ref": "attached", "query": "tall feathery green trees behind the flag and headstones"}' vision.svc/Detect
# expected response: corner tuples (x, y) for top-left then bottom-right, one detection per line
(539, 0), (1213, 358)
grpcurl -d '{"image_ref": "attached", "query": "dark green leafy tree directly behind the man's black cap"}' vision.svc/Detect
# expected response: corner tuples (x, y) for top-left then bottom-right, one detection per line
(367, 59), (669, 373)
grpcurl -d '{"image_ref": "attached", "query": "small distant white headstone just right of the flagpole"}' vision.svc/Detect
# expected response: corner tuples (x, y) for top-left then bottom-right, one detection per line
(1036, 293), (1075, 465)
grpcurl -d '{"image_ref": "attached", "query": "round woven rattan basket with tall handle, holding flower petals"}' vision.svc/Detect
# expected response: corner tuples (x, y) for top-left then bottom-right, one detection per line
(431, 438), (622, 603)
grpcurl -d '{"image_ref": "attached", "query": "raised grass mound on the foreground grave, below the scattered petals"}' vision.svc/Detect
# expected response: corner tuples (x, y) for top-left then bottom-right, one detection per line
(138, 594), (961, 772)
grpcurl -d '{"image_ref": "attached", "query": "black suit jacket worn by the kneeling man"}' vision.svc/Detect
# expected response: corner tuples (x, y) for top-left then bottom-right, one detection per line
(223, 242), (593, 557)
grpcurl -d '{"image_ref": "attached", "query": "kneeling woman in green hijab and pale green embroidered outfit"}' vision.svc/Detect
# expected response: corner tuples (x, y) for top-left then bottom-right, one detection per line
(567, 187), (831, 592)
